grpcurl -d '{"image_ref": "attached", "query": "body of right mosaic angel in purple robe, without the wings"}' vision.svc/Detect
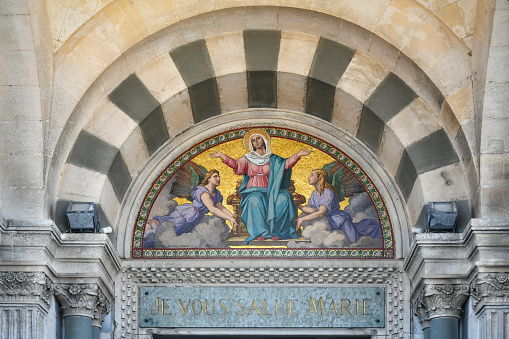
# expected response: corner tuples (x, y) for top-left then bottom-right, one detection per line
(296, 169), (382, 243)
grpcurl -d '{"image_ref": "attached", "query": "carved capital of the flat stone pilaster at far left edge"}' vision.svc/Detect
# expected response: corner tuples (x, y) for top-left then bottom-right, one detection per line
(0, 272), (53, 311)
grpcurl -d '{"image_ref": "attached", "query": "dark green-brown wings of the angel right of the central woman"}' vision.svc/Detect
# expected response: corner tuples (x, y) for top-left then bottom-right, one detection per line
(322, 161), (364, 201)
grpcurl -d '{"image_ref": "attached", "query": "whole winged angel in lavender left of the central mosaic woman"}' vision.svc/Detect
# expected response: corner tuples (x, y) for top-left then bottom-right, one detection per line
(152, 161), (237, 236)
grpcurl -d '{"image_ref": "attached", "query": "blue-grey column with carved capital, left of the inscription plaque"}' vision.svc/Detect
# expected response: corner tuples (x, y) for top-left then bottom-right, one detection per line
(55, 284), (109, 339)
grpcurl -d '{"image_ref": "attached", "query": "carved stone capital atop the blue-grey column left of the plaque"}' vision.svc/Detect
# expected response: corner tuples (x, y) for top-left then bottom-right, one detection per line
(54, 284), (109, 323)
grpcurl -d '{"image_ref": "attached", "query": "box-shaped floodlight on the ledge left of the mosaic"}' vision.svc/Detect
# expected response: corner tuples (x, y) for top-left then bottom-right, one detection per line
(66, 202), (100, 233)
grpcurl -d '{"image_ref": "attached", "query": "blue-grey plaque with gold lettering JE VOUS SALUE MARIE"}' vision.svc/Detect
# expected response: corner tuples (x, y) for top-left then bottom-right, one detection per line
(140, 286), (385, 327)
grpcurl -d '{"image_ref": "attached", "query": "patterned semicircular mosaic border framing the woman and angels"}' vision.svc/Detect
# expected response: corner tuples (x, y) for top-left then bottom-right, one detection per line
(132, 126), (394, 259)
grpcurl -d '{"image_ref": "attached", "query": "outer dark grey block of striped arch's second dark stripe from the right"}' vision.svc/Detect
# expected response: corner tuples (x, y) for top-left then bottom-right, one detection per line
(364, 73), (417, 122)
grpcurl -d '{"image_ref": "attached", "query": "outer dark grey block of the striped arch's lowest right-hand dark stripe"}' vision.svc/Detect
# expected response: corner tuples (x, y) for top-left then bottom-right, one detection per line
(406, 129), (459, 174)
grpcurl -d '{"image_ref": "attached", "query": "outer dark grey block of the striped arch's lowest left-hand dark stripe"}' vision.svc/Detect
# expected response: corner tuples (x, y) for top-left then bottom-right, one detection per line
(67, 130), (118, 174)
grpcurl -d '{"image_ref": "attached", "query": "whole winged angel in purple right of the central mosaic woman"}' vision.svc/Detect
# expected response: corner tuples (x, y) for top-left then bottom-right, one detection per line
(296, 161), (382, 243)
